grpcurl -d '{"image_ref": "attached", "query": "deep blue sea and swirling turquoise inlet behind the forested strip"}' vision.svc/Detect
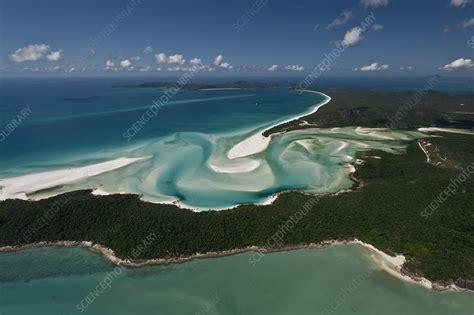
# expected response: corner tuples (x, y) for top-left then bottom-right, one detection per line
(0, 80), (423, 209)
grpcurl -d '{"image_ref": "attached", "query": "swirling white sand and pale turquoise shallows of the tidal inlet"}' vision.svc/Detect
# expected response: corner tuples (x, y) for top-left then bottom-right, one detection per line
(0, 127), (424, 210)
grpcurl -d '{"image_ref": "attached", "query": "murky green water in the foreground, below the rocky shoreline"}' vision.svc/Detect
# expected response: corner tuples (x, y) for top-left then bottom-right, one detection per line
(0, 245), (474, 315)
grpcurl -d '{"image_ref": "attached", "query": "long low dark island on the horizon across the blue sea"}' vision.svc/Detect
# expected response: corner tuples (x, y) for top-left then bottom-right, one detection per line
(112, 81), (278, 91)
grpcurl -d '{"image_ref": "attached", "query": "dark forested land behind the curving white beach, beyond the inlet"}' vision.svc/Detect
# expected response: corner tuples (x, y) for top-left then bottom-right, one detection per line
(265, 90), (474, 136)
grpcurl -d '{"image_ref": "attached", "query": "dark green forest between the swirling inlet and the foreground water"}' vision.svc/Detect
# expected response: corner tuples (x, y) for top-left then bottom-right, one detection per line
(0, 134), (474, 288)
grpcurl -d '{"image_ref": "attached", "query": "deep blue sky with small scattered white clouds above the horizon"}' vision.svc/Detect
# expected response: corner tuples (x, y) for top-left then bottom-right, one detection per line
(0, 0), (474, 76)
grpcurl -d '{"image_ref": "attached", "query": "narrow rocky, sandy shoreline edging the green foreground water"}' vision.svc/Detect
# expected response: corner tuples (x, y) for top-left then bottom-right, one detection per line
(0, 239), (474, 293)
